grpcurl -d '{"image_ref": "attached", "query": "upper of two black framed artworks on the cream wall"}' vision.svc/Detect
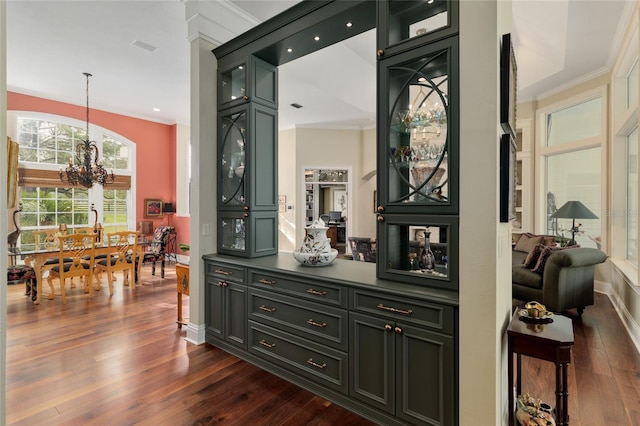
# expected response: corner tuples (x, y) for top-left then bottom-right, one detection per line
(500, 34), (518, 138)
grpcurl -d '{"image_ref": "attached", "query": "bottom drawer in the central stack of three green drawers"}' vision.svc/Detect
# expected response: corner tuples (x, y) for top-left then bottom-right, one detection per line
(249, 321), (348, 393)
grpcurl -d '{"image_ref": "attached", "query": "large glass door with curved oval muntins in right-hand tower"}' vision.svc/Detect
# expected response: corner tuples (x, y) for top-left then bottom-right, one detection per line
(378, 38), (458, 213)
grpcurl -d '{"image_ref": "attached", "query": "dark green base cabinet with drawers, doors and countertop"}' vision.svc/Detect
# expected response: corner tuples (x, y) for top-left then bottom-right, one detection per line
(204, 254), (457, 425)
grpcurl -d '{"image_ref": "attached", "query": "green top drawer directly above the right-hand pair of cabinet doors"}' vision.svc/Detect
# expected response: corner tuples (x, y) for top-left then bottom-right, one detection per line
(351, 290), (455, 334)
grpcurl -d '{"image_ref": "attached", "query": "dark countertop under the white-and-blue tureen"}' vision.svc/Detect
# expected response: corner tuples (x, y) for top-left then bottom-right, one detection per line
(202, 252), (459, 307)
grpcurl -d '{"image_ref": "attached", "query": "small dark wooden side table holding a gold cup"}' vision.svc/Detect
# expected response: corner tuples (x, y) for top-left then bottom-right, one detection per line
(507, 309), (573, 426)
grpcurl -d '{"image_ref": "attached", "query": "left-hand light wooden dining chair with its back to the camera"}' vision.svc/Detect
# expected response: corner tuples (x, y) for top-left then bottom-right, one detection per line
(47, 234), (97, 303)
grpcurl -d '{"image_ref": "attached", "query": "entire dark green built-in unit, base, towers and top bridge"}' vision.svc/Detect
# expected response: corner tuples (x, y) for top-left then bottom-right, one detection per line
(211, 0), (460, 425)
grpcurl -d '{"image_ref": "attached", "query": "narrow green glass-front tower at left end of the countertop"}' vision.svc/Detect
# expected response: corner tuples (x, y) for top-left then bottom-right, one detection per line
(217, 57), (278, 257)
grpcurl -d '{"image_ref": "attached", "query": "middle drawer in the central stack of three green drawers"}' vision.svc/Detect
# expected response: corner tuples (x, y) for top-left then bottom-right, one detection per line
(249, 288), (348, 350)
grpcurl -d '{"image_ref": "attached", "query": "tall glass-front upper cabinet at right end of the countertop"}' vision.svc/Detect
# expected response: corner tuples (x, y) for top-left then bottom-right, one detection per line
(376, 1), (459, 290)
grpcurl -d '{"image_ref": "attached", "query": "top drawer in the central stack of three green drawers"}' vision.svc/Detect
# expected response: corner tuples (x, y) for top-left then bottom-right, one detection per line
(249, 271), (347, 308)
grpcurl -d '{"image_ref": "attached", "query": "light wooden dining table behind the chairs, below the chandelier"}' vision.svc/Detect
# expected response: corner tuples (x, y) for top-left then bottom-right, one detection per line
(8, 238), (149, 305)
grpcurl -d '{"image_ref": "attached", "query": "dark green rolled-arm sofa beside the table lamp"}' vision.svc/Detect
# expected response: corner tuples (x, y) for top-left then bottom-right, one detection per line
(511, 247), (607, 315)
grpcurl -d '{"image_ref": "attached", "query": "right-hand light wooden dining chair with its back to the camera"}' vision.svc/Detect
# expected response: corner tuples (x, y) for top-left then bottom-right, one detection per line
(96, 231), (140, 294)
